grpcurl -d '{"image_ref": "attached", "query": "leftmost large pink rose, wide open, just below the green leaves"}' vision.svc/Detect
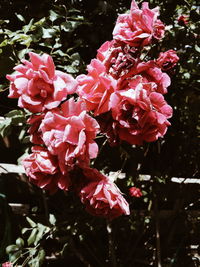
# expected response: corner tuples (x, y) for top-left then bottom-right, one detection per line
(7, 52), (76, 113)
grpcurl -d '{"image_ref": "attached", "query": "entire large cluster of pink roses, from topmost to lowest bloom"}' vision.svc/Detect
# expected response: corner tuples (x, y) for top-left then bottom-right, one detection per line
(7, 1), (178, 219)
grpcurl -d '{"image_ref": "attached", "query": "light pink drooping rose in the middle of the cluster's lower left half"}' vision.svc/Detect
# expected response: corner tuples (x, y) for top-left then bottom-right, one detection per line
(39, 98), (99, 172)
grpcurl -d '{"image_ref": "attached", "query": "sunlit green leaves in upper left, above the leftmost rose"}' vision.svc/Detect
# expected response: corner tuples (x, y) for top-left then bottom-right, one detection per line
(0, 5), (87, 79)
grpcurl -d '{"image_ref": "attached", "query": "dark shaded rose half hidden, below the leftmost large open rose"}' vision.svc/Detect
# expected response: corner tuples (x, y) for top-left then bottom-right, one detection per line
(27, 113), (45, 145)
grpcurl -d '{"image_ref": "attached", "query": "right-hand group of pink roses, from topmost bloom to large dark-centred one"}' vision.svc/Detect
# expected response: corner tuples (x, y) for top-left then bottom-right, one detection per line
(76, 1), (178, 145)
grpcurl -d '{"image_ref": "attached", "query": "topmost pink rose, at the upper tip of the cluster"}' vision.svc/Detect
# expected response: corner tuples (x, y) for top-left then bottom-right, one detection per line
(113, 1), (165, 47)
